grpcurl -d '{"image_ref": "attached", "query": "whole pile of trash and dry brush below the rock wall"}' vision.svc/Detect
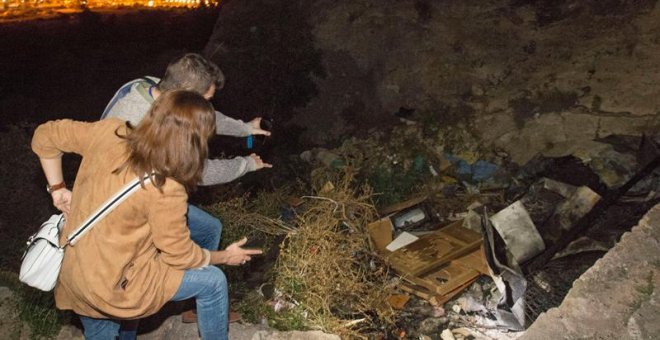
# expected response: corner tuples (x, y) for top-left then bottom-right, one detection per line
(210, 121), (660, 339)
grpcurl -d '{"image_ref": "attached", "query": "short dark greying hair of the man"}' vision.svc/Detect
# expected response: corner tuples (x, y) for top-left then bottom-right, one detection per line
(158, 53), (225, 95)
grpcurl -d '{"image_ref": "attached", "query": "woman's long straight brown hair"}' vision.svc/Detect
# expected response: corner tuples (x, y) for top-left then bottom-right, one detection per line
(115, 90), (215, 191)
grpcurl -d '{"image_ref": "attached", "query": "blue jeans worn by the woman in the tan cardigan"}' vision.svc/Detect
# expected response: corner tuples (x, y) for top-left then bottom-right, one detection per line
(80, 266), (229, 340)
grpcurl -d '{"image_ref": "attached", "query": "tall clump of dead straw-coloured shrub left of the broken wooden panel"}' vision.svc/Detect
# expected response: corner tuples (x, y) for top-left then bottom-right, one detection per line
(275, 171), (393, 337)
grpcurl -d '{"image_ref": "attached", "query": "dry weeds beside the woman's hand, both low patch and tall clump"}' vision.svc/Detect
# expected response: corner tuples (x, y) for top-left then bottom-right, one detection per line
(211, 167), (393, 337)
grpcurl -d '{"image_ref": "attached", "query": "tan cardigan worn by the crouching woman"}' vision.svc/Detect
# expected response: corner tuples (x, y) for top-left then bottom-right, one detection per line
(32, 119), (209, 319)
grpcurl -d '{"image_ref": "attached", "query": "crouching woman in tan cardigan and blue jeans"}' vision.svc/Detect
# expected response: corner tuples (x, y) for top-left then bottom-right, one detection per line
(32, 91), (260, 339)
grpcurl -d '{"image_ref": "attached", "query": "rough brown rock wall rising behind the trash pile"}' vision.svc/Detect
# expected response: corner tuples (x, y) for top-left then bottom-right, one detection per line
(207, 0), (660, 164)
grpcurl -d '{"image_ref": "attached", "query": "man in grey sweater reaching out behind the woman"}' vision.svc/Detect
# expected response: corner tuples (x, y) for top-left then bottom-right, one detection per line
(101, 53), (272, 339)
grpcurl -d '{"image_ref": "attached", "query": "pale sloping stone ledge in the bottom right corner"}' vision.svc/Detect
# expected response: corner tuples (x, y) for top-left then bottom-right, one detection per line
(520, 204), (660, 340)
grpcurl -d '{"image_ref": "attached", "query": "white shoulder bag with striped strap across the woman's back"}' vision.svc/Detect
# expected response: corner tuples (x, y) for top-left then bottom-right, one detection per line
(19, 176), (148, 291)
